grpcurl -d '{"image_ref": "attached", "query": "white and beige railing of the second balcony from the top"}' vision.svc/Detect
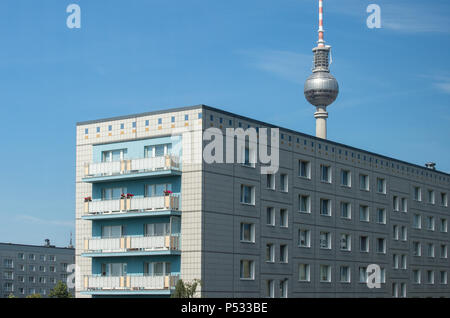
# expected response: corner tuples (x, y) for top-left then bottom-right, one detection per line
(84, 194), (179, 214)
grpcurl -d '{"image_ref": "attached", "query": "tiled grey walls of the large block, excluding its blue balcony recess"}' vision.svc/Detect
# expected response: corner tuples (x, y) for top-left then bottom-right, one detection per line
(77, 105), (450, 297)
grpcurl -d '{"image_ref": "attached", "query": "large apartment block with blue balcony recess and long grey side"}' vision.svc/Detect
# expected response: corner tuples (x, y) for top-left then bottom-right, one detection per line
(76, 105), (450, 297)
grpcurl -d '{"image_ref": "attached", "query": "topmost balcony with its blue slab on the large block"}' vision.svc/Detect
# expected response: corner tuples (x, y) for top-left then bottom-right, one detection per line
(83, 155), (180, 183)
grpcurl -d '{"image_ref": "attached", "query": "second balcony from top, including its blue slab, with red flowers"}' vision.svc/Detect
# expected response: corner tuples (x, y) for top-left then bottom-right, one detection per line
(83, 194), (180, 219)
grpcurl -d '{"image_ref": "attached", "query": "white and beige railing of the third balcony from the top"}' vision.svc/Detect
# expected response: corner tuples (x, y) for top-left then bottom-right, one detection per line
(84, 235), (180, 253)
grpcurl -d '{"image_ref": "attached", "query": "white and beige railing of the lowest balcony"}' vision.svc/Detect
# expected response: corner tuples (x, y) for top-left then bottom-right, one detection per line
(84, 275), (179, 291)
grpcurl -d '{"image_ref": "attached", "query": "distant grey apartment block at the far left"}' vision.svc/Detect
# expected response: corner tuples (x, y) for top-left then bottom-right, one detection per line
(0, 243), (75, 298)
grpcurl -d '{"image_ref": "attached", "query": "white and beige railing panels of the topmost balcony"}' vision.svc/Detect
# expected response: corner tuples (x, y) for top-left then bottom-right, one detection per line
(84, 155), (180, 178)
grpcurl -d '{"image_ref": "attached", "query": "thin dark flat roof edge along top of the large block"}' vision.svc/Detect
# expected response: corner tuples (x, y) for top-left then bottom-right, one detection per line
(77, 104), (450, 177)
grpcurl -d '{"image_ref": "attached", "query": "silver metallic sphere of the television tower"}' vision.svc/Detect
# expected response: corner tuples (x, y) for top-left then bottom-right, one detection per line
(304, 72), (339, 107)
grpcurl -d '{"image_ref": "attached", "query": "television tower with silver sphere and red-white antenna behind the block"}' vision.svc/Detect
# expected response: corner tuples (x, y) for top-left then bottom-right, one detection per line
(304, 0), (339, 139)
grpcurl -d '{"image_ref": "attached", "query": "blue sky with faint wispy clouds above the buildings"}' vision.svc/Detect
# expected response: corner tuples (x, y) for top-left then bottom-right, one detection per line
(0, 0), (450, 245)
